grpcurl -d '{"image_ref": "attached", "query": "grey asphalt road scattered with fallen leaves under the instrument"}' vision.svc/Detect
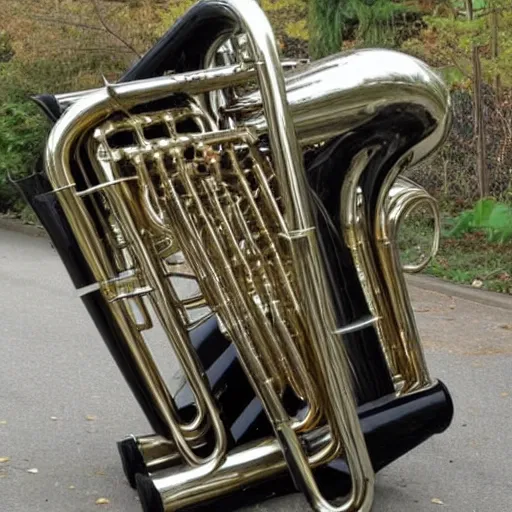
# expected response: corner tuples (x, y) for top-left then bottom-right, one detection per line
(0, 230), (512, 512)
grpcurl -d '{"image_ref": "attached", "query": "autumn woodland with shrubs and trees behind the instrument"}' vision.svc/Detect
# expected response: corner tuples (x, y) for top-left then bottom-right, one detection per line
(0, 0), (512, 294)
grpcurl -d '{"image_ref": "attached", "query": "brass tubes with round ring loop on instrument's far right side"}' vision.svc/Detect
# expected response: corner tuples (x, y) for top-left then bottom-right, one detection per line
(341, 171), (440, 394)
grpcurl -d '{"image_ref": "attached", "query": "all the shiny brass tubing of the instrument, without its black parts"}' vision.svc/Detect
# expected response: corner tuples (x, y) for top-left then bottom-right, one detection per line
(46, 0), (450, 512)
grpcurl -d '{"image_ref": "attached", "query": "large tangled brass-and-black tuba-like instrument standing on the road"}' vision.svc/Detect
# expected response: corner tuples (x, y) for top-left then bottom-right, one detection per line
(16, 0), (453, 512)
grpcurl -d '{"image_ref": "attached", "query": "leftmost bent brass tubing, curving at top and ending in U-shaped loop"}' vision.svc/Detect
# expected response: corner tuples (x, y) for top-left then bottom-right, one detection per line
(47, 64), (250, 471)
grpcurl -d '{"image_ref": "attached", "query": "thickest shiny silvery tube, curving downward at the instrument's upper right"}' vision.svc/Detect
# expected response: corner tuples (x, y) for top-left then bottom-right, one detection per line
(238, 49), (452, 166)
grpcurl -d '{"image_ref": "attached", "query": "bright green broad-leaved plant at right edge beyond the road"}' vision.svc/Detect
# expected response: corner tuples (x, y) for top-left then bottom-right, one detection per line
(448, 198), (512, 243)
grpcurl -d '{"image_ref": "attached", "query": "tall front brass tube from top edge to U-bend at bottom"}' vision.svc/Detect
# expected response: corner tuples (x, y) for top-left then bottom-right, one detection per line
(207, 0), (374, 512)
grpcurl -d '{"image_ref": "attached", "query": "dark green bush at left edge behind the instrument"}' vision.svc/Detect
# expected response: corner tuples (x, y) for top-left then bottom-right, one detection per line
(0, 101), (48, 211)
